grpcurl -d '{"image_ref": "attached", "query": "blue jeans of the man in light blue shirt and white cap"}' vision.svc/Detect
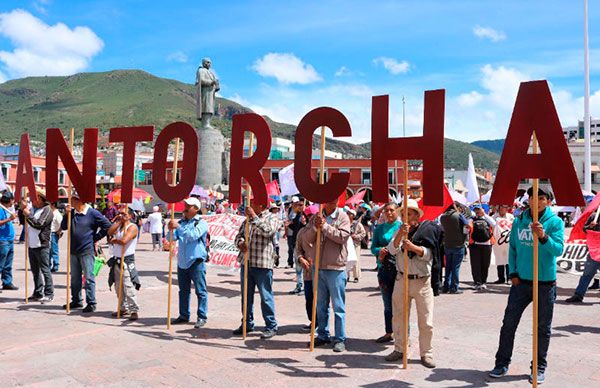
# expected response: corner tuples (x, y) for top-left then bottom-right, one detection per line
(177, 260), (208, 321)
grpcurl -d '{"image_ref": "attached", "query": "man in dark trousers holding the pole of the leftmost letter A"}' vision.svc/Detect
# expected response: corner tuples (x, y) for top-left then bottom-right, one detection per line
(21, 189), (54, 303)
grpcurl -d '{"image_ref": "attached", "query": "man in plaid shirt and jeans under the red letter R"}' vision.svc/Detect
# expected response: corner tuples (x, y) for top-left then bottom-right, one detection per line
(233, 204), (278, 339)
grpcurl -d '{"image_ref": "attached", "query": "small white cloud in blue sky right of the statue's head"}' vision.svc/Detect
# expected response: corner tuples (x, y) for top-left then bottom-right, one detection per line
(252, 53), (322, 85)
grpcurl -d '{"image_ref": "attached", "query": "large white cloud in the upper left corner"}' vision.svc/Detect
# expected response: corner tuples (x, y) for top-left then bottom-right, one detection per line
(0, 9), (104, 77)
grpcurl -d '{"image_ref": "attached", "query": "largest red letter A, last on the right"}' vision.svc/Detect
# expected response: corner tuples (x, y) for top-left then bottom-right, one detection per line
(490, 81), (585, 206)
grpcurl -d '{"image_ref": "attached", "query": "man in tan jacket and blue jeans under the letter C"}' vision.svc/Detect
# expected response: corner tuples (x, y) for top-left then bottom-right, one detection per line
(306, 198), (353, 353)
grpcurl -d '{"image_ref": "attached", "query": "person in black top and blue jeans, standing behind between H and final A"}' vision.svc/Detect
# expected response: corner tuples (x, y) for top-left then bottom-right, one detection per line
(440, 204), (469, 294)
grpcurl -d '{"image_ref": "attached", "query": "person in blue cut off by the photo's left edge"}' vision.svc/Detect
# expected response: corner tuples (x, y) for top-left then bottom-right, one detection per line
(0, 191), (19, 292)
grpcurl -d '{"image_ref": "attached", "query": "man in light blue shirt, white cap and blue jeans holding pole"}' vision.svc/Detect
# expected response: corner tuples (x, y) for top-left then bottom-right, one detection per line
(169, 198), (208, 329)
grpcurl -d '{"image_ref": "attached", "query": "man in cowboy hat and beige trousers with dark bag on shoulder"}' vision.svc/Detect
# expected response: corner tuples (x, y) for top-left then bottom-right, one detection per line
(385, 199), (443, 368)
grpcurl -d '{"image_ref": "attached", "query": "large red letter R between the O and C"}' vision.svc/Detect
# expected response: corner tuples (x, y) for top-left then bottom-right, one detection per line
(229, 113), (271, 205)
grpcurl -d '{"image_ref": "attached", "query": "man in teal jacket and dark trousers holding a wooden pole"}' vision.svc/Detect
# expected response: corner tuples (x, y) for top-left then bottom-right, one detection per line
(489, 188), (564, 384)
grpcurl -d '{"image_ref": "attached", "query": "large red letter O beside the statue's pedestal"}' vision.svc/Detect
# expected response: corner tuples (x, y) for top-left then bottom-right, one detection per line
(152, 121), (198, 203)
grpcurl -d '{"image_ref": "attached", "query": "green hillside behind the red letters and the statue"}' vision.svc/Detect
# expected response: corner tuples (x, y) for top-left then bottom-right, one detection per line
(0, 70), (499, 169)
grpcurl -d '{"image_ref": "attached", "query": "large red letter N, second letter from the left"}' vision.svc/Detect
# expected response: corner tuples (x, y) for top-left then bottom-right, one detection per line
(46, 128), (98, 202)
